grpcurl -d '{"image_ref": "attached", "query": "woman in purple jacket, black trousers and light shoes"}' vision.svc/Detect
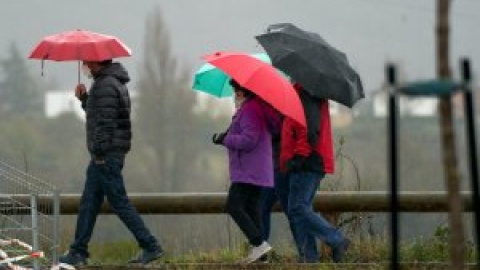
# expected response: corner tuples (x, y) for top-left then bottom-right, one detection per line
(212, 80), (273, 263)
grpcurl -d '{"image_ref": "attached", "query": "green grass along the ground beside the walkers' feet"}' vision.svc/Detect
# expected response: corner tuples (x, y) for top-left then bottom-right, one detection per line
(86, 228), (475, 269)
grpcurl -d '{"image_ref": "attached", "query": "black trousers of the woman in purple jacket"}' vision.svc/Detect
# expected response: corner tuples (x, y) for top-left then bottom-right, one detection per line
(225, 183), (264, 246)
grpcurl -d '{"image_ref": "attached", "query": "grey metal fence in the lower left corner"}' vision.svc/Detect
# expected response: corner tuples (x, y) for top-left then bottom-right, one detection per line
(0, 160), (60, 269)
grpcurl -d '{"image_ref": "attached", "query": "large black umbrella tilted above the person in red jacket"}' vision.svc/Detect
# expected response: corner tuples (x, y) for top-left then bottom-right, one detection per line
(255, 23), (365, 108)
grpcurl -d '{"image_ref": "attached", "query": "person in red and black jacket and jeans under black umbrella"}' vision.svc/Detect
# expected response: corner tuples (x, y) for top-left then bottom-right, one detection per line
(280, 84), (350, 262)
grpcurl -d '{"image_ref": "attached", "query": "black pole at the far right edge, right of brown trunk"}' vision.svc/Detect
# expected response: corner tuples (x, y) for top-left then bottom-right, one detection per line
(460, 58), (480, 267)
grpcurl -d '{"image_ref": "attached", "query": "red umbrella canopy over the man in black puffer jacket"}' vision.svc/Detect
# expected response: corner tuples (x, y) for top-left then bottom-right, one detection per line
(29, 30), (132, 61)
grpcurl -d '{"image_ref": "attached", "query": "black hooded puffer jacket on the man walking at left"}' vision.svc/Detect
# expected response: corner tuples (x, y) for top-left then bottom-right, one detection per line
(81, 63), (132, 157)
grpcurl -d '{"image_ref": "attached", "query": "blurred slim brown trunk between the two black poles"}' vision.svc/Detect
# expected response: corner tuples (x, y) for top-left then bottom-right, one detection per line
(436, 0), (464, 269)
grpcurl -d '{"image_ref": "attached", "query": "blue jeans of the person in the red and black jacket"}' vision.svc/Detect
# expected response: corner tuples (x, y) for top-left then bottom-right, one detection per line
(287, 172), (345, 255)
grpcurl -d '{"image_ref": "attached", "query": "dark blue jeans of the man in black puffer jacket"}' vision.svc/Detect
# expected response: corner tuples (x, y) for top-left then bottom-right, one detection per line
(70, 157), (160, 257)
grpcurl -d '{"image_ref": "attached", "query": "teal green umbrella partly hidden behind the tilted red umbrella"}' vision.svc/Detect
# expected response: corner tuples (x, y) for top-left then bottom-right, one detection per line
(192, 53), (271, 97)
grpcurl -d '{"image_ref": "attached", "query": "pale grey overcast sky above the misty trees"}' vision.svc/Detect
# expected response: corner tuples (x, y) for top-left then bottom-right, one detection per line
(0, 0), (480, 94)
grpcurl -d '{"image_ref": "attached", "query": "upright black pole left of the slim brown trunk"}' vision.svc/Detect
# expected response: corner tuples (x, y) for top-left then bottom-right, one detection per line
(386, 64), (399, 270)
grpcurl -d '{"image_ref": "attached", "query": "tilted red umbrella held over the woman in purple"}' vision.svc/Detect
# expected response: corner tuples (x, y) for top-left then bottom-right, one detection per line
(204, 52), (307, 127)
